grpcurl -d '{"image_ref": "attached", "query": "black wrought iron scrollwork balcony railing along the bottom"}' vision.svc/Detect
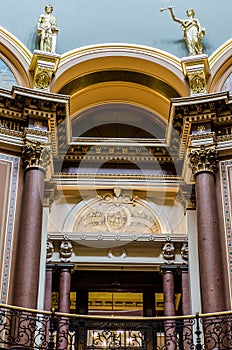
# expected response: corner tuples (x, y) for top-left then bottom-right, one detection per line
(0, 304), (232, 350)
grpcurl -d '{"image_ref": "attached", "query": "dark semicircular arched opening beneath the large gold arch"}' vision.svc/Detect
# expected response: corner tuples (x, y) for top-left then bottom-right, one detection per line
(72, 103), (166, 139)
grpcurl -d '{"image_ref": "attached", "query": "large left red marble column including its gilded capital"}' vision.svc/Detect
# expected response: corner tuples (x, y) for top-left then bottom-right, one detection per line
(13, 140), (50, 309)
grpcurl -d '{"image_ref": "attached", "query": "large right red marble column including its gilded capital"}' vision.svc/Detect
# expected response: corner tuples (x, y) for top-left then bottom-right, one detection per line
(190, 144), (226, 313)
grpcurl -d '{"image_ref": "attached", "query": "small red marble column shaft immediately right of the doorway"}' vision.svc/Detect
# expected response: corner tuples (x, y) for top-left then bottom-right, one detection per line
(163, 269), (175, 316)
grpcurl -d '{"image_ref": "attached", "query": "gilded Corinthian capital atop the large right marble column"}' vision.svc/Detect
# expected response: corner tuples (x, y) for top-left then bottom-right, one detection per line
(189, 144), (218, 175)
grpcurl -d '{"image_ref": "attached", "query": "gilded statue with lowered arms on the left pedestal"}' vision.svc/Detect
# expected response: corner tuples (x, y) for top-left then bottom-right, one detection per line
(37, 5), (58, 52)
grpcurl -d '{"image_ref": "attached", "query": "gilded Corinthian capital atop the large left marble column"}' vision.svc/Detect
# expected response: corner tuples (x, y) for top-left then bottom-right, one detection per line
(22, 139), (51, 171)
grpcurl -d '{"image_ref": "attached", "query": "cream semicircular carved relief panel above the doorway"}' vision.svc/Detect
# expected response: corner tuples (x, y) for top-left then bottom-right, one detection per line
(73, 191), (162, 234)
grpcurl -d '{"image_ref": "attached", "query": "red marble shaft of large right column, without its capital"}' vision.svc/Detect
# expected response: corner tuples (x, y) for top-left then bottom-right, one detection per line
(195, 171), (226, 313)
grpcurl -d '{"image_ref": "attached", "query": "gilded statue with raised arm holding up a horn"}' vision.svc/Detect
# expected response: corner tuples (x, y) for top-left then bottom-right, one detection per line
(167, 6), (205, 55)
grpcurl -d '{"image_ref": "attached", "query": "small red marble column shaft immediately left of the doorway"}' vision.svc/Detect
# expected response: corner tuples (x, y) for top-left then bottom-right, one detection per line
(59, 265), (71, 313)
